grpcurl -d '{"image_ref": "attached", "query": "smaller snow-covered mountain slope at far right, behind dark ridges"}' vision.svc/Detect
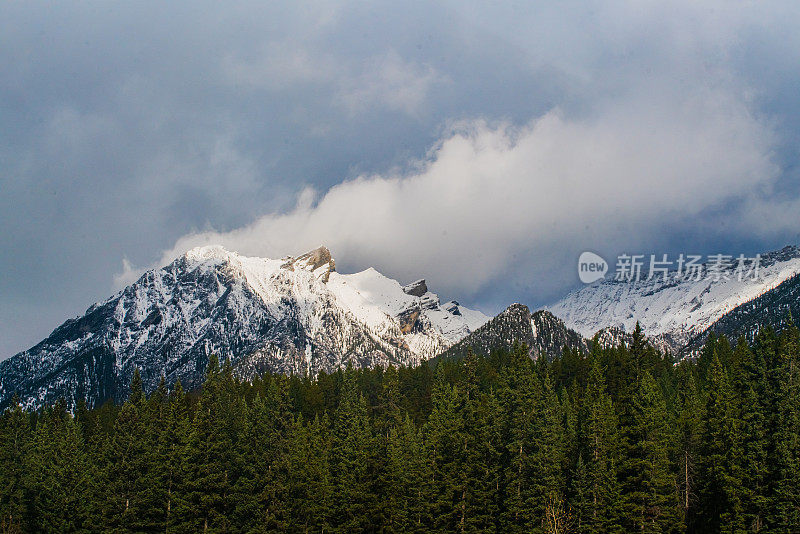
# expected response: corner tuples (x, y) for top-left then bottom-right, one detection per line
(548, 246), (800, 353)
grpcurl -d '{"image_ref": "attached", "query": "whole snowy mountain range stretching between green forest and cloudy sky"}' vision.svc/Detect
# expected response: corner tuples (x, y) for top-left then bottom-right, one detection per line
(0, 246), (800, 407)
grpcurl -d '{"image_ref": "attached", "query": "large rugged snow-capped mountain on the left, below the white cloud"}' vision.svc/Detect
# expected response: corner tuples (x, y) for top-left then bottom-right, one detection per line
(0, 247), (489, 406)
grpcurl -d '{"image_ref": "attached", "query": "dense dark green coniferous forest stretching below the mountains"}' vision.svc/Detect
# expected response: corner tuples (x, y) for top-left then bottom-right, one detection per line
(0, 327), (800, 533)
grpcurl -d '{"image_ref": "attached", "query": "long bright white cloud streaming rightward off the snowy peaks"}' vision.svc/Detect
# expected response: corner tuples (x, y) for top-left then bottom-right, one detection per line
(134, 81), (779, 304)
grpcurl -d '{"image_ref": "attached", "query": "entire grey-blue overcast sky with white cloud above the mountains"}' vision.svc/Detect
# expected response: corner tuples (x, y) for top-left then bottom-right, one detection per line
(0, 0), (800, 358)
